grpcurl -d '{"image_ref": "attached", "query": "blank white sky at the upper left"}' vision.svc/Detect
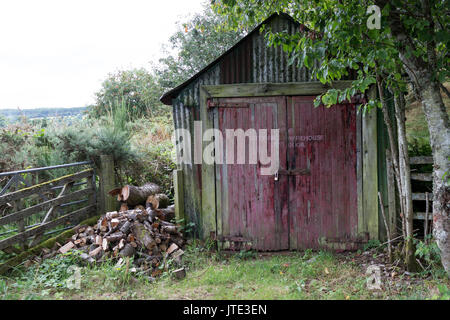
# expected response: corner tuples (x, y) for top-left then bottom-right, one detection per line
(0, 0), (203, 109)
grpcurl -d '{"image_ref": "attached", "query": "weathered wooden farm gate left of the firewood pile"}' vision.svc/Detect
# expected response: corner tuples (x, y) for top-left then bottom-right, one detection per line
(0, 162), (98, 253)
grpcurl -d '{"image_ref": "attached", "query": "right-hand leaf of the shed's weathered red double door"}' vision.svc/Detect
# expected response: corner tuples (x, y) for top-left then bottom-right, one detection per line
(287, 96), (358, 249)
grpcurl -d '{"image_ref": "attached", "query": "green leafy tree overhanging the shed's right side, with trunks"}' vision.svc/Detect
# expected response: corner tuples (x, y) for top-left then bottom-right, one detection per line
(212, 0), (450, 273)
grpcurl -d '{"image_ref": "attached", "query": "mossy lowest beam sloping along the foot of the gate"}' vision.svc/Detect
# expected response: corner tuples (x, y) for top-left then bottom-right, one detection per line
(0, 215), (100, 274)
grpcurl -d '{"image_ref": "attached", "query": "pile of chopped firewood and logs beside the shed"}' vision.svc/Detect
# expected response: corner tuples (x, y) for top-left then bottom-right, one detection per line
(58, 184), (184, 277)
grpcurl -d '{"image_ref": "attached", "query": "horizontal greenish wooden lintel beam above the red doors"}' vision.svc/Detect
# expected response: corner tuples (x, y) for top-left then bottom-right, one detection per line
(200, 80), (352, 98)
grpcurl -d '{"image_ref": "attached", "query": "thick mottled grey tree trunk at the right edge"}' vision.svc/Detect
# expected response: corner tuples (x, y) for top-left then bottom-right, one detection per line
(376, 0), (450, 275)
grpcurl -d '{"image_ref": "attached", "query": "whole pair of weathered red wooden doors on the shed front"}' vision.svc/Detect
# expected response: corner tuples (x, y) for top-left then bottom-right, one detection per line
(215, 96), (358, 251)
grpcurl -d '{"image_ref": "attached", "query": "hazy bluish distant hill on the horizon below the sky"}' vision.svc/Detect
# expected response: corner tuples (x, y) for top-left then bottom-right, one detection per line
(0, 107), (87, 121)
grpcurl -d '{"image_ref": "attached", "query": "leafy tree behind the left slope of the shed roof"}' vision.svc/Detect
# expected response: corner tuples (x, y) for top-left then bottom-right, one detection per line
(155, 7), (244, 89)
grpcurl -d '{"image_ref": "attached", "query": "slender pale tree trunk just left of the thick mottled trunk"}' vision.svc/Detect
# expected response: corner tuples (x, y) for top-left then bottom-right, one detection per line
(394, 93), (418, 272)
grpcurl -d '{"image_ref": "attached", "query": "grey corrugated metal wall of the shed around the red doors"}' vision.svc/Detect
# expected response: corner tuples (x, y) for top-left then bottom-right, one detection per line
(172, 16), (387, 240)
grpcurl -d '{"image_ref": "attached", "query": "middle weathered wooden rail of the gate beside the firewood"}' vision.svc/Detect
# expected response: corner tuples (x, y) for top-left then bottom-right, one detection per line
(0, 189), (93, 226)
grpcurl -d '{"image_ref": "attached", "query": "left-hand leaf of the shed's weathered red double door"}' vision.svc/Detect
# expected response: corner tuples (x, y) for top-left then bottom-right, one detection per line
(216, 97), (289, 251)
